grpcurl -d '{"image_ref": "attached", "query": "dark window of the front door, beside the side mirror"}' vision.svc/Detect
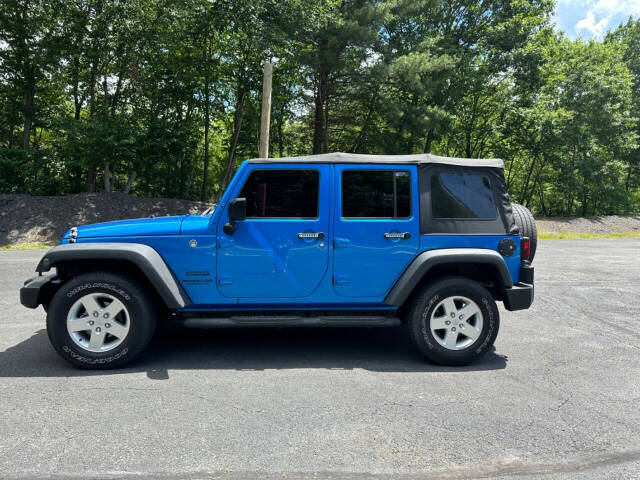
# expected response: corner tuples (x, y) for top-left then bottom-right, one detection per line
(239, 170), (320, 218)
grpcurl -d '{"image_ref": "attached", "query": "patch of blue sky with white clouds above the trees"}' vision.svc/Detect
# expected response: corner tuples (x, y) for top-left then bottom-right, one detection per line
(555, 0), (640, 39)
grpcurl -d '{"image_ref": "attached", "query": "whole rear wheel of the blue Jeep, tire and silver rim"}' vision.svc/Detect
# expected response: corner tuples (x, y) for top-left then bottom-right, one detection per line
(405, 277), (500, 365)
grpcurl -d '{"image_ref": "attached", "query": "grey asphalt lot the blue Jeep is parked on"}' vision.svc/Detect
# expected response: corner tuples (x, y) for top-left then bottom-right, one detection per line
(0, 239), (640, 479)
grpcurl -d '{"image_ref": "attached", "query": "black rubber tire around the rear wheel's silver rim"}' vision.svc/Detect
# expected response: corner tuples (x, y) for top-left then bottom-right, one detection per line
(405, 277), (500, 366)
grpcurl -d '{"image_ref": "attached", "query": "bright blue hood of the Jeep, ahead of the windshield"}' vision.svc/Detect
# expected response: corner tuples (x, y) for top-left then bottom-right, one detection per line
(64, 215), (186, 239)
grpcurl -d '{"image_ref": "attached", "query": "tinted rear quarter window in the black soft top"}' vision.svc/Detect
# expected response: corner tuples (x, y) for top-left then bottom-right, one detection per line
(431, 172), (497, 220)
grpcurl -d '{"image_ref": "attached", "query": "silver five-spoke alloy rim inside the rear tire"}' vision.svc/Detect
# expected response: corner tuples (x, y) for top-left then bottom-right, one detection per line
(429, 295), (483, 350)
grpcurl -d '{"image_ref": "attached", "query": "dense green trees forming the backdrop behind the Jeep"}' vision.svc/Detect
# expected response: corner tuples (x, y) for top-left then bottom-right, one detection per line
(0, 0), (640, 215)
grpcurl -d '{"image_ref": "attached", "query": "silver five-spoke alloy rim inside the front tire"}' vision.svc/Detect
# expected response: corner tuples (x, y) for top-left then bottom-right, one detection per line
(67, 293), (131, 353)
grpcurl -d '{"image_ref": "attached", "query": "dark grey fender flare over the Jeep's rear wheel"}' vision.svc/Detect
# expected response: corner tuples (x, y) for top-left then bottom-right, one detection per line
(384, 248), (513, 306)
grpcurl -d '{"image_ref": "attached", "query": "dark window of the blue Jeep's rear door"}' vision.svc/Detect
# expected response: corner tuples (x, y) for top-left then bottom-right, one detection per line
(342, 170), (411, 218)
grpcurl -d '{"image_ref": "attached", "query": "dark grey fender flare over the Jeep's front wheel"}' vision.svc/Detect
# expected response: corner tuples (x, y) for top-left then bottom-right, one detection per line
(36, 242), (191, 309)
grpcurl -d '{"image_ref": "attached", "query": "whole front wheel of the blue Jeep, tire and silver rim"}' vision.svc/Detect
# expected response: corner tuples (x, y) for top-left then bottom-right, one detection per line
(47, 272), (156, 369)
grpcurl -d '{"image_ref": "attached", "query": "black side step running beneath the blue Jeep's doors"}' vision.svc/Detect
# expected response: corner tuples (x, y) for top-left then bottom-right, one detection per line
(180, 315), (401, 328)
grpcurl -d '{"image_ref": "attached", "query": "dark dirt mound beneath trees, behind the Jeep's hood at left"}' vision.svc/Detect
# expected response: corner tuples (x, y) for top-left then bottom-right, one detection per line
(0, 193), (215, 246)
